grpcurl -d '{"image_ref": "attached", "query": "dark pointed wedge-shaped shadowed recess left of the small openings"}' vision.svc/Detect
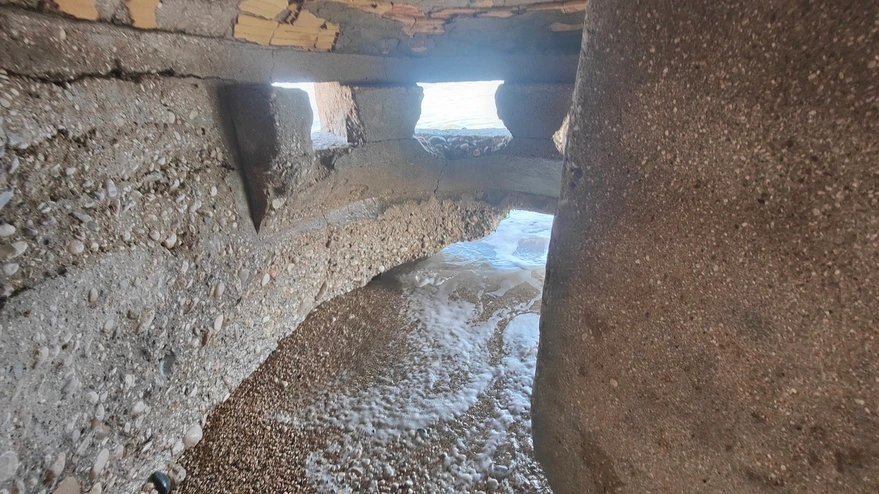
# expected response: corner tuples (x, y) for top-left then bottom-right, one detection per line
(215, 84), (280, 232)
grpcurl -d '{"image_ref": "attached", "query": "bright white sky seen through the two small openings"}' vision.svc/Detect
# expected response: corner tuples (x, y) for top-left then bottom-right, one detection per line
(274, 81), (506, 133)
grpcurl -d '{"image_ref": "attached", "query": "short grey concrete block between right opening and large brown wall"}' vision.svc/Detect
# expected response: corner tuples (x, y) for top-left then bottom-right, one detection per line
(495, 82), (574, 139)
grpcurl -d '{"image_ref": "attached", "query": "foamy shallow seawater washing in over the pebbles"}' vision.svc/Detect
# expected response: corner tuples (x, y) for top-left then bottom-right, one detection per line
(286, 211), (552, 492)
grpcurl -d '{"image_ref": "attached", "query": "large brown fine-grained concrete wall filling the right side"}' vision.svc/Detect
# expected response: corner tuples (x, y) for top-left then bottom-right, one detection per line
(533, 0), (879, 493)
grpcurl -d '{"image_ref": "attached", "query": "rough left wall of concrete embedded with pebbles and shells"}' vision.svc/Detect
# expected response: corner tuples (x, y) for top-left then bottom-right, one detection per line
(0, 72), (503, 493)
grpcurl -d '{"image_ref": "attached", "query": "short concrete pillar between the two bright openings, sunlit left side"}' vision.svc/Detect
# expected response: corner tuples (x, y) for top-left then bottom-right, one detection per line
(315, 82), (424, 144)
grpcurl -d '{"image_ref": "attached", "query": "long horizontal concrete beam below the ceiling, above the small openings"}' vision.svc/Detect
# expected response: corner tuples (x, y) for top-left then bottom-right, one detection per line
(0, 6), (578, 83)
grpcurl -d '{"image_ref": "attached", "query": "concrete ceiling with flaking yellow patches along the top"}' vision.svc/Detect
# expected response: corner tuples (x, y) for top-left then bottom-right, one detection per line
(36, 0), (586, 57)
